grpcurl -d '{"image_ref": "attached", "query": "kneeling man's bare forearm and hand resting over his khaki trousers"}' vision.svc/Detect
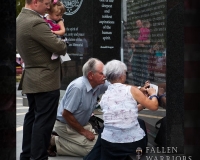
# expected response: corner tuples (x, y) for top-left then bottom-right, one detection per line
(62, 109), (95, 141)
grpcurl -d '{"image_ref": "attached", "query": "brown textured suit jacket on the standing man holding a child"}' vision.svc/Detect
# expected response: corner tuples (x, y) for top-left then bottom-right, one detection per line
(16, 8), (67, 93)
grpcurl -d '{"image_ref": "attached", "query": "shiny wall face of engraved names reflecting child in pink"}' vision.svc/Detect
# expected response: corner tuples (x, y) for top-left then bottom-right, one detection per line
(123, 0), (167, 86)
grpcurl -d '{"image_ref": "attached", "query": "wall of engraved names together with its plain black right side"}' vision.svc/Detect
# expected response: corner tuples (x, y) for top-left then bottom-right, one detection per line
(122, 0), (184, 154)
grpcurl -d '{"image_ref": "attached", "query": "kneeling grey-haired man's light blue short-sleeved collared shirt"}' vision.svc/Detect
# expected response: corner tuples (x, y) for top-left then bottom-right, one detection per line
(57, 76), (108, 126)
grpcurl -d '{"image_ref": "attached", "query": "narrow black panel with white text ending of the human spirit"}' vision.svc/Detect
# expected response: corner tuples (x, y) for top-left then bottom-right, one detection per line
(93, 0), (121, 63)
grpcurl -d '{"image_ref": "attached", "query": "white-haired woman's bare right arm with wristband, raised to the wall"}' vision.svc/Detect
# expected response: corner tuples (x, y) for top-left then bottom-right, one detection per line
(131, 86), (158, 110)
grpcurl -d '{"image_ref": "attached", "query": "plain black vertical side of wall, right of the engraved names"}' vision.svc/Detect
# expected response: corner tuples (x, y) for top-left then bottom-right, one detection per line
(166, 0), (184, 154)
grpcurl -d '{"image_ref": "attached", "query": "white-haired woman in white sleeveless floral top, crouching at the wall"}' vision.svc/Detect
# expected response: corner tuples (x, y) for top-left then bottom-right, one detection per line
(84, 60), (158, 160)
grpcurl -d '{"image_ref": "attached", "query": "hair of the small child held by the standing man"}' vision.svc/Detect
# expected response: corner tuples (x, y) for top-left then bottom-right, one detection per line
(48, 0), (66, 15)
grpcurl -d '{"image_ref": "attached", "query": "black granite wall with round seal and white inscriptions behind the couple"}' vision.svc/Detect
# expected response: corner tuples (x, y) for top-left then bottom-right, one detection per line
(61, 0), (121, 89)
